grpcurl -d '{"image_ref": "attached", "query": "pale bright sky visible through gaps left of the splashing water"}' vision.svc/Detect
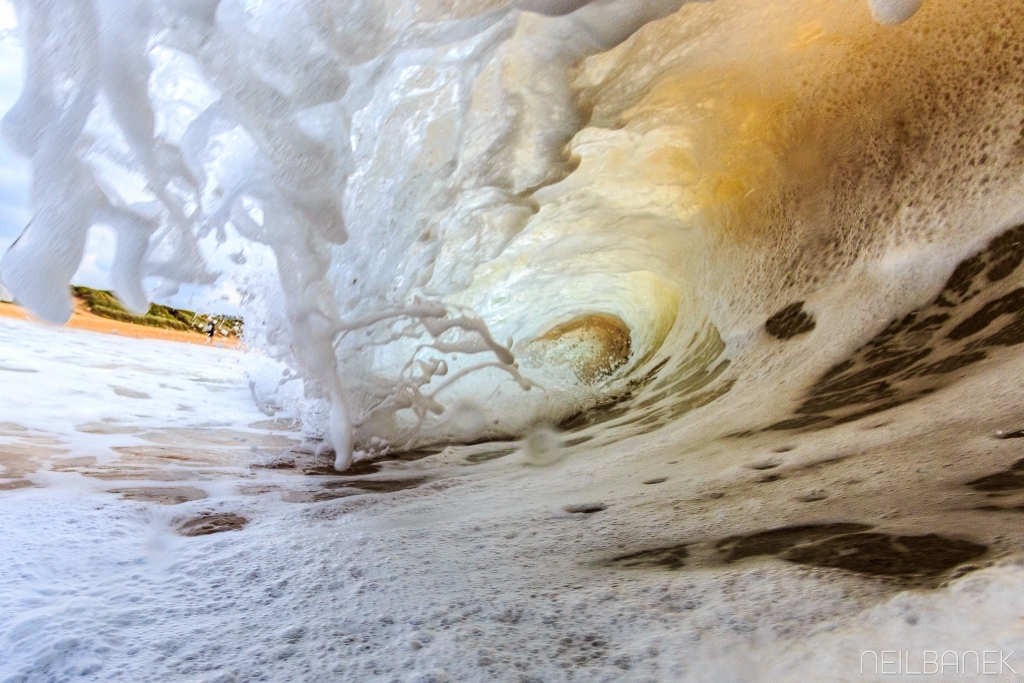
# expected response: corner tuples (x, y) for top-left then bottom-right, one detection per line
(0, 0), (245, 314)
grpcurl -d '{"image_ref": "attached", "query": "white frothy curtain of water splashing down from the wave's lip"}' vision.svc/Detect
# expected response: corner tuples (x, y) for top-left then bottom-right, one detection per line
(3, 0), (700, 464)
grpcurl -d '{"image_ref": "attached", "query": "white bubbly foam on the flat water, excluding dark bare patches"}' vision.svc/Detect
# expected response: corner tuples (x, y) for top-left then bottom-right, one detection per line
(0, 321), (1024, 683)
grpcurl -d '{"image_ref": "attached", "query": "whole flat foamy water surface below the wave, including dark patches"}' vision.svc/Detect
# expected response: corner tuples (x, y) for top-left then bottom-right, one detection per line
(0, 321), (1024, 683)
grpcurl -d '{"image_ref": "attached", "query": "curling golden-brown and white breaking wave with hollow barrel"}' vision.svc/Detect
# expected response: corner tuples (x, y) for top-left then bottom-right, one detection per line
(0, 0), (1024, 468)
